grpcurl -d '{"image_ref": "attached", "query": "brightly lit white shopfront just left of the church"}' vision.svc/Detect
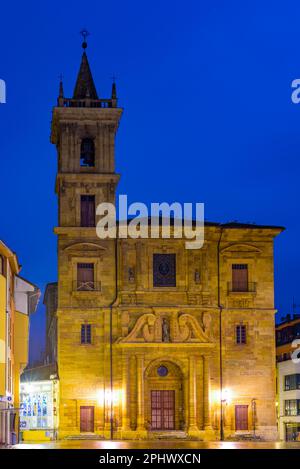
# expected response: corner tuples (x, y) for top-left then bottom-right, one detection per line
(20, 381), (53, 430)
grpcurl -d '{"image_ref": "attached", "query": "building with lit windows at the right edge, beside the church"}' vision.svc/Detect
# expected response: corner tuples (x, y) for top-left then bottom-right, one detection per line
(276, 314), (300, 441)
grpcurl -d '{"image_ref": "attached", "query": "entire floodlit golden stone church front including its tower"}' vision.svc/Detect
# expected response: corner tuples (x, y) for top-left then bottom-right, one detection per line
(52, 46), (281, 440)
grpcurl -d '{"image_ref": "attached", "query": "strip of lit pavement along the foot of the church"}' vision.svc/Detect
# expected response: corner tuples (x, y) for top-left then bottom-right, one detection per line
(8, 440), (300, 450)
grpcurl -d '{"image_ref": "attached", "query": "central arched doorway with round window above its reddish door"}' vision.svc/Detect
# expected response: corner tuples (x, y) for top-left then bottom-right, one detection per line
(145, 360), (185, 431)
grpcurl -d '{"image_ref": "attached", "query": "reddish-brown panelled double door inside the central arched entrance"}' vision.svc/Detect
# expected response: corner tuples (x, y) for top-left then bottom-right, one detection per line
(151, 390), (175, 430)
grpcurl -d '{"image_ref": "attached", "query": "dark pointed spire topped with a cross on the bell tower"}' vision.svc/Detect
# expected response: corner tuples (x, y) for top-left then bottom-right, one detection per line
(73, 29), (99, 99)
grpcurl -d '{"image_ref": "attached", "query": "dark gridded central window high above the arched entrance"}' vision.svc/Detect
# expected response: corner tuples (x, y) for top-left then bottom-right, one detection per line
(153, 254), (176, 287)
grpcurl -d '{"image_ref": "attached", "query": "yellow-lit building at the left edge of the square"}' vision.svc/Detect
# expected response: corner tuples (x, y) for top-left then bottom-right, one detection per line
(0, 241), (40, 444)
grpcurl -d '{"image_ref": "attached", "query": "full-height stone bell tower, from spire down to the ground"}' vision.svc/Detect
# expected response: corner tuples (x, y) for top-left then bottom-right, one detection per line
(51, 40), (122, 437)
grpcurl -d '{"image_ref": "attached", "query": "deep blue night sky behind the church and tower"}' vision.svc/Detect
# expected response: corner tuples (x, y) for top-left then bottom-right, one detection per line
(0, 0), (300, 358)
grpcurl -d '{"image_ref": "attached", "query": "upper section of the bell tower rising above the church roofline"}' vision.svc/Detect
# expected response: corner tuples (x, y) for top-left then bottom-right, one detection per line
(51, 41), (122, 227)
